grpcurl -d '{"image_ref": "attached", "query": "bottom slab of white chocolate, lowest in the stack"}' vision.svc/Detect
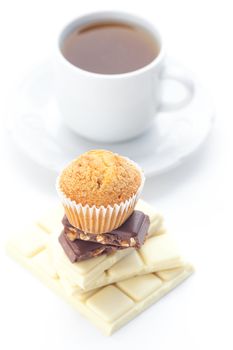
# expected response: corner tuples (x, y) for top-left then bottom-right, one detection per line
(7, 237), (193, 335)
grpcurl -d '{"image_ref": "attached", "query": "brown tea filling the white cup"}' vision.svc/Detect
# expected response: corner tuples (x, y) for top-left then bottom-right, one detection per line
(61, 22), (159, 74)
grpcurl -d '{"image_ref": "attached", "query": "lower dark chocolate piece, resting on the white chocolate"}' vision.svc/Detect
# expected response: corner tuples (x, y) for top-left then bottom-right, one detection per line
(58, 231), (121, 263)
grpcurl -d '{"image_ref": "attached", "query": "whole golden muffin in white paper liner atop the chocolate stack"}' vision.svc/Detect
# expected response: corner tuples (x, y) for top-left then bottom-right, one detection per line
(56, 150), (144, 234)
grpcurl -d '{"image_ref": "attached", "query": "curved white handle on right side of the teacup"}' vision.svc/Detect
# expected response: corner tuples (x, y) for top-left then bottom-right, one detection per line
(158, 63), (195, 112)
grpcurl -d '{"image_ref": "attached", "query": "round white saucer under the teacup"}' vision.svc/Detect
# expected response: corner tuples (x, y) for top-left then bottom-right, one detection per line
(7, 59), (214, 176)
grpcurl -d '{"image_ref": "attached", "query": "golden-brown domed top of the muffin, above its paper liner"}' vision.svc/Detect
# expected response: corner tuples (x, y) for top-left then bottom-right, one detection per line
(59, 150), (142, 207)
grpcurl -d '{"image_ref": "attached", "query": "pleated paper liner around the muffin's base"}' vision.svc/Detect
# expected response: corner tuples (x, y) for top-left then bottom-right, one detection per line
(56, 157), (145, 234)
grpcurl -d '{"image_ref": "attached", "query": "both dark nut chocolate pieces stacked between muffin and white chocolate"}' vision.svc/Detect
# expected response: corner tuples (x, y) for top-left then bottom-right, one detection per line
(59, 210), (150, 263)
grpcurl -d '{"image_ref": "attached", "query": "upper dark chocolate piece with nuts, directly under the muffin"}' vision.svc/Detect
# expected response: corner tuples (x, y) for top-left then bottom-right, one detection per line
(62, 210), (150, 248)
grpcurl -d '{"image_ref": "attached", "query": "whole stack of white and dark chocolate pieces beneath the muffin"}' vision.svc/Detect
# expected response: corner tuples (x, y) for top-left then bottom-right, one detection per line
(8, 200), (193, 335)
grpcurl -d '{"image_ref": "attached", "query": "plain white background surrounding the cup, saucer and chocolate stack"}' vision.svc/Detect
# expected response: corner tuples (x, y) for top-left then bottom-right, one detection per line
(0, 0), (233, 350)
